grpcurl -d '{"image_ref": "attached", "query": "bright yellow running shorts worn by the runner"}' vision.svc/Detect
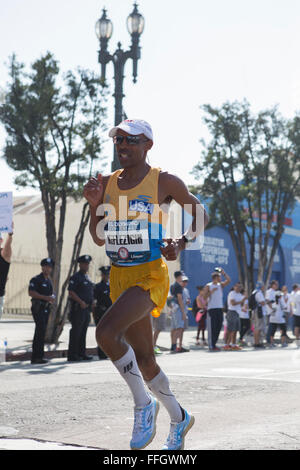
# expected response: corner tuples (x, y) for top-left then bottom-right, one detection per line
(110, 258), (170, 317)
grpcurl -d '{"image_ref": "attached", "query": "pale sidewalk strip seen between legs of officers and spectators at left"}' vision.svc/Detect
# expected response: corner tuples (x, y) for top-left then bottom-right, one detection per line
(0, 317), (202, 362)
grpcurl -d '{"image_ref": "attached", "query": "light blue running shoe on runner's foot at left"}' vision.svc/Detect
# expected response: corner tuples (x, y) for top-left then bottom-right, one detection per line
(130, 397), (159, 450)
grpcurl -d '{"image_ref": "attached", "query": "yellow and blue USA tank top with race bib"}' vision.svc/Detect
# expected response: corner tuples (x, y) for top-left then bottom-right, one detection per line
(103, 167), (168, 266)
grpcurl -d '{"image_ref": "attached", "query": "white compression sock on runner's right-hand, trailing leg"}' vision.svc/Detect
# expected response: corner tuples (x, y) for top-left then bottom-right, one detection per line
(146, 370), (183, 423)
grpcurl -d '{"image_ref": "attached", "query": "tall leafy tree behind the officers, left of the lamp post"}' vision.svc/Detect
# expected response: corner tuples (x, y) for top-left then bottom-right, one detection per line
(0, 52), (106, 342)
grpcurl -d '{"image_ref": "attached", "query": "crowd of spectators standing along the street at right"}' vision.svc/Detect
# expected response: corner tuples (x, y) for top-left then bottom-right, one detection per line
(154, 268), (300, 354)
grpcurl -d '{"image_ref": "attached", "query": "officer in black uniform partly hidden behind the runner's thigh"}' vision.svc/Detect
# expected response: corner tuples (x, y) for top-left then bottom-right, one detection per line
(93, 266), (112, 359)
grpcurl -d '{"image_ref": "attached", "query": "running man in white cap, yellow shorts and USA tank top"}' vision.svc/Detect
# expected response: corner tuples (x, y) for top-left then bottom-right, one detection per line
(84, 120), (208, 450)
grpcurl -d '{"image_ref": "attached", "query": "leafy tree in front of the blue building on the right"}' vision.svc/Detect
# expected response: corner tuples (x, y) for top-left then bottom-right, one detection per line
(193, 101), (300, 289)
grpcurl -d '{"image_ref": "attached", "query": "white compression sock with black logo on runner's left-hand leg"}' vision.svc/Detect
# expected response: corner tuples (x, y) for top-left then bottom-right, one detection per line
(113, 345), (151, 407)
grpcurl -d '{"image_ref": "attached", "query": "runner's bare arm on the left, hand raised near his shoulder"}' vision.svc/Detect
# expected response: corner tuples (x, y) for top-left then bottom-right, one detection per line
(83, 175), (109, 246)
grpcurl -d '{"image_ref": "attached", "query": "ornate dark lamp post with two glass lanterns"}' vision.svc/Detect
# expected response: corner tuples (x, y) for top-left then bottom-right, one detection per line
(96, 3), (145, 171)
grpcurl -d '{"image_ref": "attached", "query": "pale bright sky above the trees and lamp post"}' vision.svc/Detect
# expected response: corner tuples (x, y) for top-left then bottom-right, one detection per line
(0, 0), (300, 194)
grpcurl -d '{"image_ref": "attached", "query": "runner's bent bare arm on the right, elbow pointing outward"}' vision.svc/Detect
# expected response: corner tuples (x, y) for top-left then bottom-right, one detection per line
(158, 172), (209, 261)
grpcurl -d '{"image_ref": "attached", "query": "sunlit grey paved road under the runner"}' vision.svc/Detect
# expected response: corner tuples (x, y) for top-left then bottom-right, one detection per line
(0, 333), (300, 450)
